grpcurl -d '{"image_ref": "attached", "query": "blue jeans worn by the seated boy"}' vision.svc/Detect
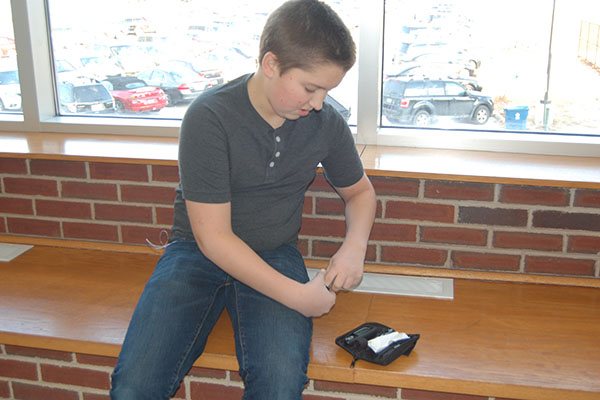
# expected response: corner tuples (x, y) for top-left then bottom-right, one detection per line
(111, 241), (312, 400)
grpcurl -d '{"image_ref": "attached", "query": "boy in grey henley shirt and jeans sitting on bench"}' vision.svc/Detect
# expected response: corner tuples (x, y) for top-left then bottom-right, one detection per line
(111, 0), (375, 400)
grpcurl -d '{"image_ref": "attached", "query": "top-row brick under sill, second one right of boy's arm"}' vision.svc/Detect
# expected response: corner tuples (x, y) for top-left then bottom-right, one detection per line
(425, 181), (494, 201)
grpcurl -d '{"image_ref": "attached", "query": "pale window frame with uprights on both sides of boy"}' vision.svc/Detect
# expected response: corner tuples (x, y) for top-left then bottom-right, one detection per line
(0, 0), (600, 157)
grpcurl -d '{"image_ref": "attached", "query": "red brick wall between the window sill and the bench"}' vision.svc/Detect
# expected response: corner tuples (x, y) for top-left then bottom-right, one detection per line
(0, 158), (600, 278)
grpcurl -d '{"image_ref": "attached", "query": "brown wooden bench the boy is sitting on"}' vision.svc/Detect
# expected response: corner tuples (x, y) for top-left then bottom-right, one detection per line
(0, 241), (600, 400)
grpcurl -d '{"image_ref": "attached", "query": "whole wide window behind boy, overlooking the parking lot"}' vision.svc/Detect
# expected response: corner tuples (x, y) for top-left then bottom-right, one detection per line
(0, 0), (600, 156)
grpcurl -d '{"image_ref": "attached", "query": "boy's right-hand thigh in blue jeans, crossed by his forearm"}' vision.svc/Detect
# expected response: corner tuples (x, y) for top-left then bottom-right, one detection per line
(227, 246), (312, 399)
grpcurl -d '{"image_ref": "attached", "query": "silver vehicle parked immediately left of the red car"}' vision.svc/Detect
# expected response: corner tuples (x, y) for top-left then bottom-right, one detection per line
(58, 79), (115, 114)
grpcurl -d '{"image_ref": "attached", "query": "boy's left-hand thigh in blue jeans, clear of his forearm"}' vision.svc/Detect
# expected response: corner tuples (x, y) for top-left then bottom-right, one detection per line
(113, 242), (230, 398)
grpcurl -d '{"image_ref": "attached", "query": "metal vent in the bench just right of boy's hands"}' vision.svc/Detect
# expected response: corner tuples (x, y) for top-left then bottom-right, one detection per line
(308, 268), (454, 300)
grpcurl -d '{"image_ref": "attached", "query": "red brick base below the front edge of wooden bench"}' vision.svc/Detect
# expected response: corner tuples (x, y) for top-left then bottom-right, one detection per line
(0, 345), (516, 400)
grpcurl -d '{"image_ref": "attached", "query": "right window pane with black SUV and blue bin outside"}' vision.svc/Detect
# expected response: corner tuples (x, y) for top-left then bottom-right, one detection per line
(381, 0), (600, 145)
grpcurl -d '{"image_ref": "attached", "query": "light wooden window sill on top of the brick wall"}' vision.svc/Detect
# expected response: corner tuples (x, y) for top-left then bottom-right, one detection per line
(0, 132), (600, 188)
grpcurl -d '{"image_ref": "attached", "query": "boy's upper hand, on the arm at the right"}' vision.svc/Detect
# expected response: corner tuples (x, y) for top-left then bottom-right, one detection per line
(325, 243), (364, 292)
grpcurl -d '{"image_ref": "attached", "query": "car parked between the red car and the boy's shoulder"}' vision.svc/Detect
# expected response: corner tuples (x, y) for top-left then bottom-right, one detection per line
(137, 68), (213, 106)
